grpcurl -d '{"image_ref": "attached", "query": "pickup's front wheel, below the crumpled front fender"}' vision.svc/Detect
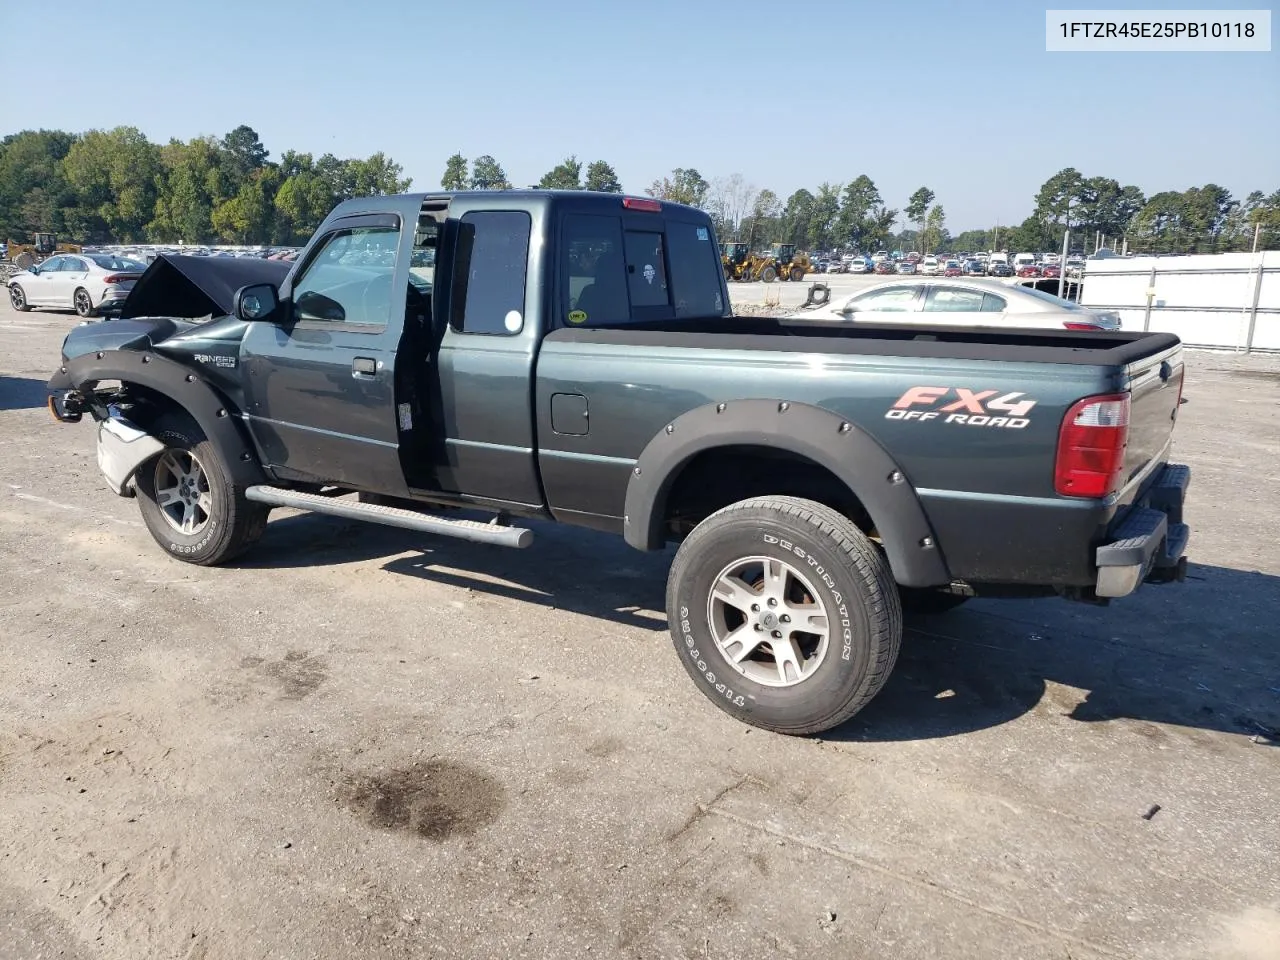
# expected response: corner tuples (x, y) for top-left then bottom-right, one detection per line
(137, 420), (269, 567)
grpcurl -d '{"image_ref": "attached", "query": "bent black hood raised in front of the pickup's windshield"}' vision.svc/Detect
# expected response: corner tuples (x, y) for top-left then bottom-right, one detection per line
(119, 253), (293, 320)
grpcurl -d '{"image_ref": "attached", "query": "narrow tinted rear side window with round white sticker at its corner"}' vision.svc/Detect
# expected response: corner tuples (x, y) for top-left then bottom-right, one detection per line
(455, 210), (532, 337)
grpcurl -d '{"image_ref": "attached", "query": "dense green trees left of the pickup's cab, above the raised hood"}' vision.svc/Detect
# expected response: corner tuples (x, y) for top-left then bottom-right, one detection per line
(0, 124), (411, 244)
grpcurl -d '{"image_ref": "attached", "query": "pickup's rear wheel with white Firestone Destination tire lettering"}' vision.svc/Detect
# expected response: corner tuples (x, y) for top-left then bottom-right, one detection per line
(667, 497), (902, 735)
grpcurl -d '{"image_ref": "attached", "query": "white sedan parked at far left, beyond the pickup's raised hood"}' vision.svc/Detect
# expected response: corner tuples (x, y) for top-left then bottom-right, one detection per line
(9, 253), (147, 317)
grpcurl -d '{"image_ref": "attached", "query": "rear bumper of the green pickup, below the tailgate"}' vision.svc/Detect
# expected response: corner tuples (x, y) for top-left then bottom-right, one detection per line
(1094, 463), (1192, 598)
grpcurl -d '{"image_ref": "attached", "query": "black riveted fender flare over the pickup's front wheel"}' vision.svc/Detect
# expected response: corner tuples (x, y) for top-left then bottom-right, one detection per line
(49, 351), (268, 486)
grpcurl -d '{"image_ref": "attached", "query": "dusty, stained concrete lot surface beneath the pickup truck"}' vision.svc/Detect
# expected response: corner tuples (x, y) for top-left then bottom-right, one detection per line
(0, 302), (1280, 960)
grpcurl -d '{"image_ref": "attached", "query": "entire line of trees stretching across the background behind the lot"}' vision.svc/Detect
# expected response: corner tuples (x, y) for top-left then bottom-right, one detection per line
(0, 124), (1280, 253)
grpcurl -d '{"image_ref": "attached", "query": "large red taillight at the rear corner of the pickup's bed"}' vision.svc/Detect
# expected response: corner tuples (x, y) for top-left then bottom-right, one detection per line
(1053, 393), (1129, 497)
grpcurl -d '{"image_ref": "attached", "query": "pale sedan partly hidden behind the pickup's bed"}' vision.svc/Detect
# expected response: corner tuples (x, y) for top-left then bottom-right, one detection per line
(787, 278), (1120, 330)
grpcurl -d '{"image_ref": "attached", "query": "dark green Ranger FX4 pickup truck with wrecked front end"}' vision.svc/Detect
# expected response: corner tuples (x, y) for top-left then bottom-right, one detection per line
(50, 192), (1189, 733)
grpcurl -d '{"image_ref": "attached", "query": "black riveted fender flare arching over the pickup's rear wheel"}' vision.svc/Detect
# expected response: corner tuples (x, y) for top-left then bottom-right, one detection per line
(623, 399), (951, 586)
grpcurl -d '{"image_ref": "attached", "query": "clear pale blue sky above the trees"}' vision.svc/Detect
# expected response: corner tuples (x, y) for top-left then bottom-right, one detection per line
(0, 0), (1280, 232)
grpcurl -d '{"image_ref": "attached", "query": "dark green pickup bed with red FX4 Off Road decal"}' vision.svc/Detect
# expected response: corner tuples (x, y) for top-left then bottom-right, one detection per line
(535, 317), (1181, 584)
